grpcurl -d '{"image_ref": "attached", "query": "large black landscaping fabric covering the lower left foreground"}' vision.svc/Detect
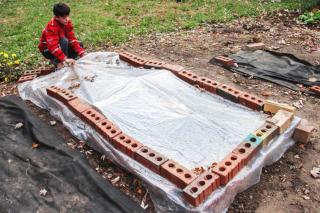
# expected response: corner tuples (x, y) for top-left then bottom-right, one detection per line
(0, 96), (143, 213)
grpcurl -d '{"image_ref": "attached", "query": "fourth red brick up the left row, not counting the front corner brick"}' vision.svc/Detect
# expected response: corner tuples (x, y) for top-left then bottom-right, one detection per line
(95, 119), (122, 145)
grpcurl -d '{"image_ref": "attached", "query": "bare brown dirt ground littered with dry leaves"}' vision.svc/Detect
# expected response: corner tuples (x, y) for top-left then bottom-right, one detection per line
(0, 11), (320, 212)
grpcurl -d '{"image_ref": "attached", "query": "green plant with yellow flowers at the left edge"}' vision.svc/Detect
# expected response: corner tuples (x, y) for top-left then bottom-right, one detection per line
(0, 51), (20, 82)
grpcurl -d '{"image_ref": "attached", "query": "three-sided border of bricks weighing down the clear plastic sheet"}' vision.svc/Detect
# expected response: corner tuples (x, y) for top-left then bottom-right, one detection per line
(41, 52), (312, 206)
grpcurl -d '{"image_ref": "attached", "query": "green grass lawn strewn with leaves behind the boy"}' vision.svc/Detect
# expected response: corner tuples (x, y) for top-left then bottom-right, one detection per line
(0, 0), (300, 66)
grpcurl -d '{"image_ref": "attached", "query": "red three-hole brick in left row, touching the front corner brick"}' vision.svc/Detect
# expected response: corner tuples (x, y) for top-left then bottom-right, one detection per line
(160, 160), (196, 189)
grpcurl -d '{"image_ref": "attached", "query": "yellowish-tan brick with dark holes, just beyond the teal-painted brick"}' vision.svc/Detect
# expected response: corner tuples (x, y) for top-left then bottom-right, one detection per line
(253, 123), (279, 146)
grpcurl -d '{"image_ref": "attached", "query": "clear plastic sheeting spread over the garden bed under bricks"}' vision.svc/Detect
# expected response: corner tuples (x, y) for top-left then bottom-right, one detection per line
(18, 52), (299, 212)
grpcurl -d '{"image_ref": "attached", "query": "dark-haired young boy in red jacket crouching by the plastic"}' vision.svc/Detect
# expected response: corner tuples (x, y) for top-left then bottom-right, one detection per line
(38, 3), (85, 68)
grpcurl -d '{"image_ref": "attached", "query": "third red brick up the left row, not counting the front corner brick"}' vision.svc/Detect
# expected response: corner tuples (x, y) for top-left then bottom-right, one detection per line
(113, 133), (143, 158)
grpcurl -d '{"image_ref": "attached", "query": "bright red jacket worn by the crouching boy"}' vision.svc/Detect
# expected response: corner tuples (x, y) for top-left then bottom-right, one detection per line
(38, 18), (84, 62)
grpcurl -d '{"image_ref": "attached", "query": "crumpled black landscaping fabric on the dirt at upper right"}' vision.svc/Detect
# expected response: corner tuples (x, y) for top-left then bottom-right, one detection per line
(211, 50), (320, 90)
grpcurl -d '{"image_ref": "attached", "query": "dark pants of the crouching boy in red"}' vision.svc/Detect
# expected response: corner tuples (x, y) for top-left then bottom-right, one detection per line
(42, 38), (83, 65)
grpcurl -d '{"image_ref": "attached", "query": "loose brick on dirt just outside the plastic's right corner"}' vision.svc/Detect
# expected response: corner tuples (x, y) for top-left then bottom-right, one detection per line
(293, 119), (315, 143)
